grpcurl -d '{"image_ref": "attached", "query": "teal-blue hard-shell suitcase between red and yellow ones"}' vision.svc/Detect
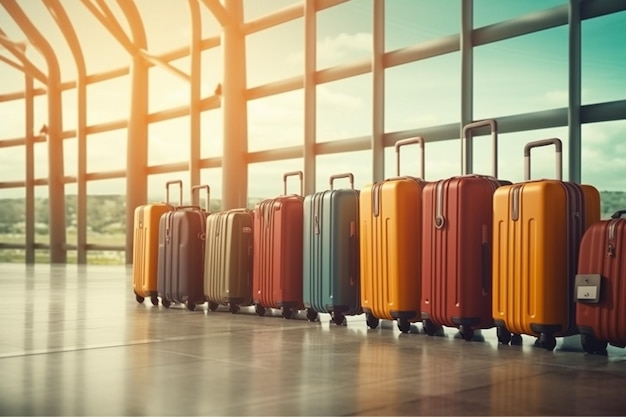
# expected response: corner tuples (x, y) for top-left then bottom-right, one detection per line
(302, 173), (361, 325)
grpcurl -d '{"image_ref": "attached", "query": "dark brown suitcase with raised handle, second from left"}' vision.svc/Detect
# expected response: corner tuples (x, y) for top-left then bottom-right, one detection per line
(157, 185), (210, 311)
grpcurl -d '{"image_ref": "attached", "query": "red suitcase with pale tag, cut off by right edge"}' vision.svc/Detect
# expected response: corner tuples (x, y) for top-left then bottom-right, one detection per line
(575, 210), (626, 353)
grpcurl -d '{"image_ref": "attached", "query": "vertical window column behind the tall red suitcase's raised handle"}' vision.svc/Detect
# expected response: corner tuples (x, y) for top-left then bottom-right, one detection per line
(459, 0), (472, 174)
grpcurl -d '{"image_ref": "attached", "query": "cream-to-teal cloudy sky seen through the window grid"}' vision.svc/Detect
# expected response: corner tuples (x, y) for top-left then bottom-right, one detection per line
(0, 0), (626, 205)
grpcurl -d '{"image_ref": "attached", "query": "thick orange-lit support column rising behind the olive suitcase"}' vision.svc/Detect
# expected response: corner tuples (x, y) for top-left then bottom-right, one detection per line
(221, 0), (248, 210)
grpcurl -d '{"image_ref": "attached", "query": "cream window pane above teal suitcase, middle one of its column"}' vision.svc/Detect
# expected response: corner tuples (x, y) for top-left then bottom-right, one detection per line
(316, 74), (372, 142)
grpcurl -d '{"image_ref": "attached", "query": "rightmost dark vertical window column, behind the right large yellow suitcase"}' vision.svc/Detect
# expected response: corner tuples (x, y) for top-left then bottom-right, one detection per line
(567, 0), (582, 183)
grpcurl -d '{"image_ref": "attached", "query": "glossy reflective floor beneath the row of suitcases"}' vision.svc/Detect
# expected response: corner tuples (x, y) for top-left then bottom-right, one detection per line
(0, 264), (626, 416)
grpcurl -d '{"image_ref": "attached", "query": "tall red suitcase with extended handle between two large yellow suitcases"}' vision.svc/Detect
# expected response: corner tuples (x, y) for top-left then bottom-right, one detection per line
(421, 120), (511, 341)
